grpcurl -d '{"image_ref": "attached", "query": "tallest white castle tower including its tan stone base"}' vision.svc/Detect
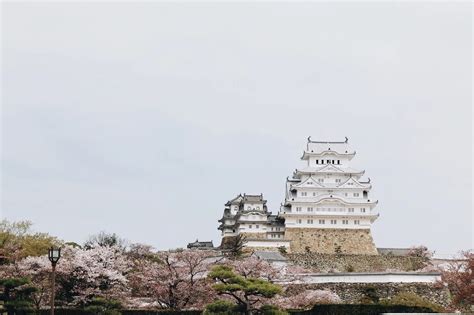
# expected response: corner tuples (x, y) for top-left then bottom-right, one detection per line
(279, 138), (378, 255)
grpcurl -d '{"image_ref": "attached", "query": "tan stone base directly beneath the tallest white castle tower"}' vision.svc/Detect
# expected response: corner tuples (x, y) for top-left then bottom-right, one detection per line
(285, 228), (378, 255)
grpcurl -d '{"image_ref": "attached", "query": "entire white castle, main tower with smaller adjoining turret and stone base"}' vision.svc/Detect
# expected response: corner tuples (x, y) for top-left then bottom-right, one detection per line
(219, 137), (378, 255)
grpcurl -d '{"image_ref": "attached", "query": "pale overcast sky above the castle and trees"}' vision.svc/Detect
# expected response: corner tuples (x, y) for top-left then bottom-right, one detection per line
(1, 2), (473, 254)
